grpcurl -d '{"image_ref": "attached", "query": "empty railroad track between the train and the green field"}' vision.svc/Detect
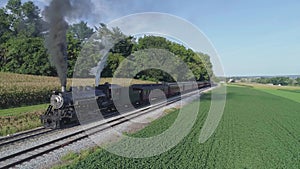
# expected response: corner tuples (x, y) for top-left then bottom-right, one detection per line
(0, 88), (209, 169)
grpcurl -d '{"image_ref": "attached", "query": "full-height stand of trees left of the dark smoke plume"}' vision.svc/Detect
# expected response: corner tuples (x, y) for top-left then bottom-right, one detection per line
(0, 0), (51, 75)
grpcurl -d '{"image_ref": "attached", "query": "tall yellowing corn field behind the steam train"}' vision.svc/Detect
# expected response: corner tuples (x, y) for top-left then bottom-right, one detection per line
(0, 72), (155, 109)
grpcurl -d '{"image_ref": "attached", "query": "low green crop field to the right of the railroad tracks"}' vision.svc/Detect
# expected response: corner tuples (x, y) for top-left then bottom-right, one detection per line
(54, 86), (300, 169)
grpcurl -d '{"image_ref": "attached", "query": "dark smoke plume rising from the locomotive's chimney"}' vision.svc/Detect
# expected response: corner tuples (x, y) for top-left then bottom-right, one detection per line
(43, 0), (92, 86)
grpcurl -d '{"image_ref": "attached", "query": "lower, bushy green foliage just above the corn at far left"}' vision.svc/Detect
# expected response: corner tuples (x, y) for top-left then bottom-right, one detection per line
(1, 37), (56, 76)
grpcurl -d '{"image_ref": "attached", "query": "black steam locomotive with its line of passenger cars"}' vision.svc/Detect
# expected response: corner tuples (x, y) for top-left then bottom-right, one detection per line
(41, 82), (211, 129)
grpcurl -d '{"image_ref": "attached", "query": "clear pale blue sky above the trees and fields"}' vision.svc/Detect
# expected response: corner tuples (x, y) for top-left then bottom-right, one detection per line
(0, 0), (300, 76)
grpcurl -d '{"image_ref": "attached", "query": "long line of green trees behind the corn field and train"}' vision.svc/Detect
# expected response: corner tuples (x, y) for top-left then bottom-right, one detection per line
(0, 0), (213, 81)
